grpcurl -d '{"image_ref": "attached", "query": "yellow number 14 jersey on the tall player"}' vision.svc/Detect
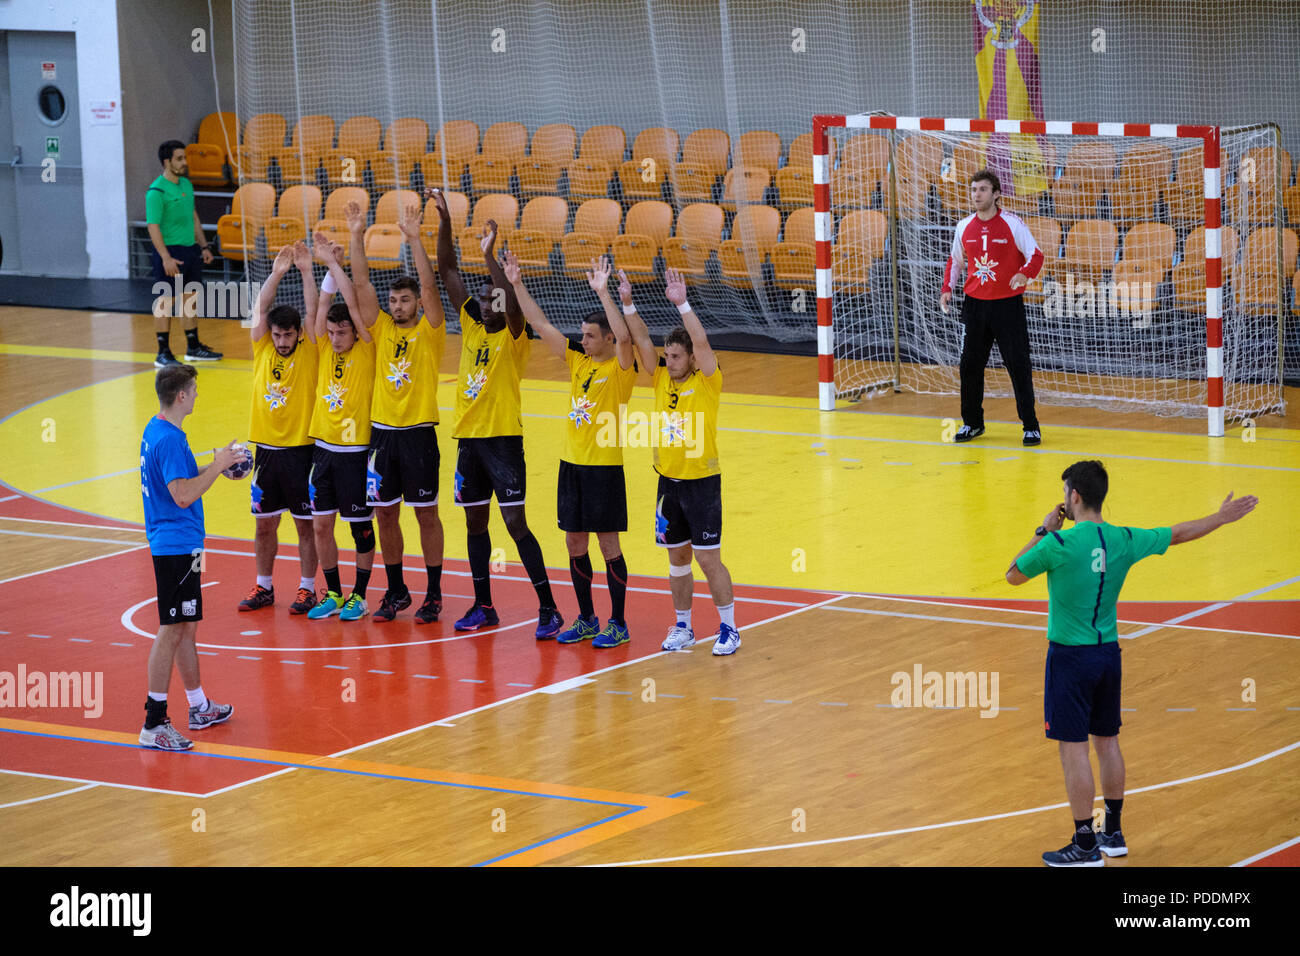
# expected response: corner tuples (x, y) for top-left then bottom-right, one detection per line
(451, 298), (532, 438)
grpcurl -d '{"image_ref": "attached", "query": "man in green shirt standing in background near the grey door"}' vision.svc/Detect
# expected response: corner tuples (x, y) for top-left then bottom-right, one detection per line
(144, 139), (221, 368)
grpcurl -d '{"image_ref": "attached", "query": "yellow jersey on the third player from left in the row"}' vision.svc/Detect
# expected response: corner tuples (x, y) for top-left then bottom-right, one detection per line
(371, 310), (447, 428)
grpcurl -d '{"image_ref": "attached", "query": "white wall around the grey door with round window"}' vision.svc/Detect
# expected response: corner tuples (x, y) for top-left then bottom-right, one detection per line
(0, 0), (127, 278)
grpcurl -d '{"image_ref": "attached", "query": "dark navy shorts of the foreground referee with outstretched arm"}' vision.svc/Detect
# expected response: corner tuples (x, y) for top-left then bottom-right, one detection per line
(1043, 641), (1119, 743)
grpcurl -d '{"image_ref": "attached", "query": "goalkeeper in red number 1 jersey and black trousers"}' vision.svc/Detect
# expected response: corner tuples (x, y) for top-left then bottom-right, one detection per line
(939, 169), (1043, 445)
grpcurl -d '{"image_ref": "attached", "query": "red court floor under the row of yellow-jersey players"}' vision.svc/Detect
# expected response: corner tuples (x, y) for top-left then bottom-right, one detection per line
(0, 489), (831, 795)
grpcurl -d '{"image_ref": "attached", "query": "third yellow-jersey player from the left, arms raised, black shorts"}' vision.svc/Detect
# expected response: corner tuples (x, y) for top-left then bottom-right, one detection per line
(346, 203), (447, 624)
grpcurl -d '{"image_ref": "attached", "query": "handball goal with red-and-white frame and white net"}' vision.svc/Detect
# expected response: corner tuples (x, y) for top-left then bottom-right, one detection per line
(814, 114), (1294, 434)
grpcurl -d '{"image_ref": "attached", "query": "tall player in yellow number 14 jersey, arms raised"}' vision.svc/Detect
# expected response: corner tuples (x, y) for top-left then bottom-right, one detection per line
(433, 190), (564, 640)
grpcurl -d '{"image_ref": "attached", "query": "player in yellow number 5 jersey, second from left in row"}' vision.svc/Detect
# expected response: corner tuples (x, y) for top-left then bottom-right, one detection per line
(307, 233), (374, 620)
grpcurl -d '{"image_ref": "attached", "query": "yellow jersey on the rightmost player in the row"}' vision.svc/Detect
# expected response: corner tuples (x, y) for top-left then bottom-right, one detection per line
(650, 356), (723, 479)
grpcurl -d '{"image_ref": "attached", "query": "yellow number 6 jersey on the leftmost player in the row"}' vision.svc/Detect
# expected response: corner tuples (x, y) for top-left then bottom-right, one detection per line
(248, 330), (319, 449)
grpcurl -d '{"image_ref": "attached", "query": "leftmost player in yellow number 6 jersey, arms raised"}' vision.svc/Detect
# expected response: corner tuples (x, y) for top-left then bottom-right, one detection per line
(239, 242), (317, 614)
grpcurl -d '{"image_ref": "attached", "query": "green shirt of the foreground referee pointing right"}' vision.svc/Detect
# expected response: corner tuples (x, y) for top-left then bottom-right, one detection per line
(1015, 522), (1173, 644)
